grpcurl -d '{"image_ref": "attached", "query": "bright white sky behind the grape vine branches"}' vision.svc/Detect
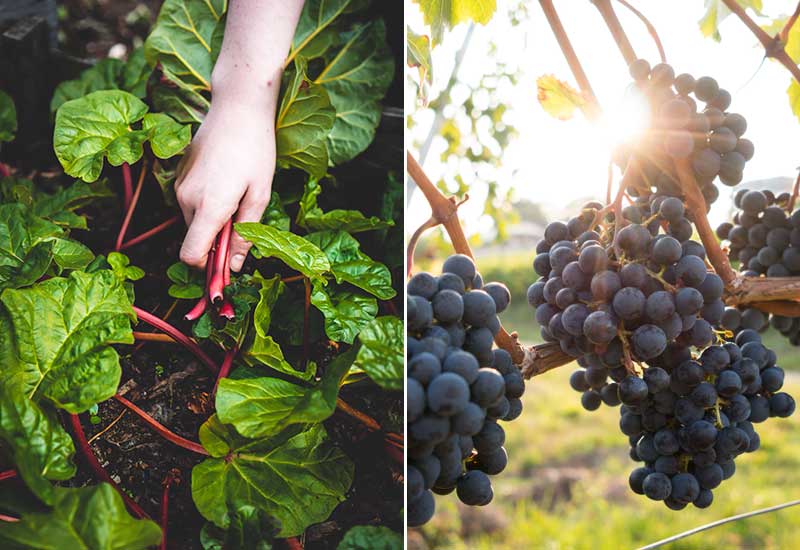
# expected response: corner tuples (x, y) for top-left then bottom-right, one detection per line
(406, 0), (800, 242)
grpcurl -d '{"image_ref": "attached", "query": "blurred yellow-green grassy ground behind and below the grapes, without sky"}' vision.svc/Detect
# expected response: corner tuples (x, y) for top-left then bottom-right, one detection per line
(409, 256), (800, 550)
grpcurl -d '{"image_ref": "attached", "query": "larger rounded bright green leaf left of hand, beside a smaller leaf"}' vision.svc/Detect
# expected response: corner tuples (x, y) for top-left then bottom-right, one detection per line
(53, 90), (148, 182)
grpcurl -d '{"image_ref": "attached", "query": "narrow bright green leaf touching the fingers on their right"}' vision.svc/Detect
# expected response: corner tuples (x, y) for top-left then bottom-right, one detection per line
(234, 222), (331, 284)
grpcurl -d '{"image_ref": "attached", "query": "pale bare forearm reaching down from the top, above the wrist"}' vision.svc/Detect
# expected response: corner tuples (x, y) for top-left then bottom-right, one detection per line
(211, 0), (304, 112)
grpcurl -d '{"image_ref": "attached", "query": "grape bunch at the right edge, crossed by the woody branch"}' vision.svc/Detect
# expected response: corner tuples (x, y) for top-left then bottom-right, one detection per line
(716, 189), (800, 346)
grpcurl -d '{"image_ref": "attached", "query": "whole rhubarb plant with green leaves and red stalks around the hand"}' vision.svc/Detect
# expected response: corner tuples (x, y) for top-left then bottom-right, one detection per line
(0, 0), (403, 548)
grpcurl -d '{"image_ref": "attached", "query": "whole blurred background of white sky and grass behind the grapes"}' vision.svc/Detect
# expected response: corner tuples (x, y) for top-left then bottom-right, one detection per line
(405, 0), (800, 549)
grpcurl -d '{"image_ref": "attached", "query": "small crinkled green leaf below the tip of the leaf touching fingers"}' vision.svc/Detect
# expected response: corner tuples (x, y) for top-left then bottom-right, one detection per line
(311, 282), (378, 344)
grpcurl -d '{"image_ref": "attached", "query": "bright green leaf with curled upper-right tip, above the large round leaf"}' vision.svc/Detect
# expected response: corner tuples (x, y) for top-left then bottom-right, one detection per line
(216, 347), (358, 438)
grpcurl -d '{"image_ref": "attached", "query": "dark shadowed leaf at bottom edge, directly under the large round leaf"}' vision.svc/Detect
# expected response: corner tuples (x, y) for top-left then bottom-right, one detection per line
(200, 505), (281, 550)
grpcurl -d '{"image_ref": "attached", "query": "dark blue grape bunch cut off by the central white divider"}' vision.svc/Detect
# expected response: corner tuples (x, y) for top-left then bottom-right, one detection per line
(406, 254), (525, 527)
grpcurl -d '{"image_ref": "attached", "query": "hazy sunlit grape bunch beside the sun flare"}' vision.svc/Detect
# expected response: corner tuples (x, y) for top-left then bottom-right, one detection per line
(616, 59), (755, 208)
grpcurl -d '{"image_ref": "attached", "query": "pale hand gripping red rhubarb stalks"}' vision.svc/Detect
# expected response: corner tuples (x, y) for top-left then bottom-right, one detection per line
(175, 97), (275, 271)
